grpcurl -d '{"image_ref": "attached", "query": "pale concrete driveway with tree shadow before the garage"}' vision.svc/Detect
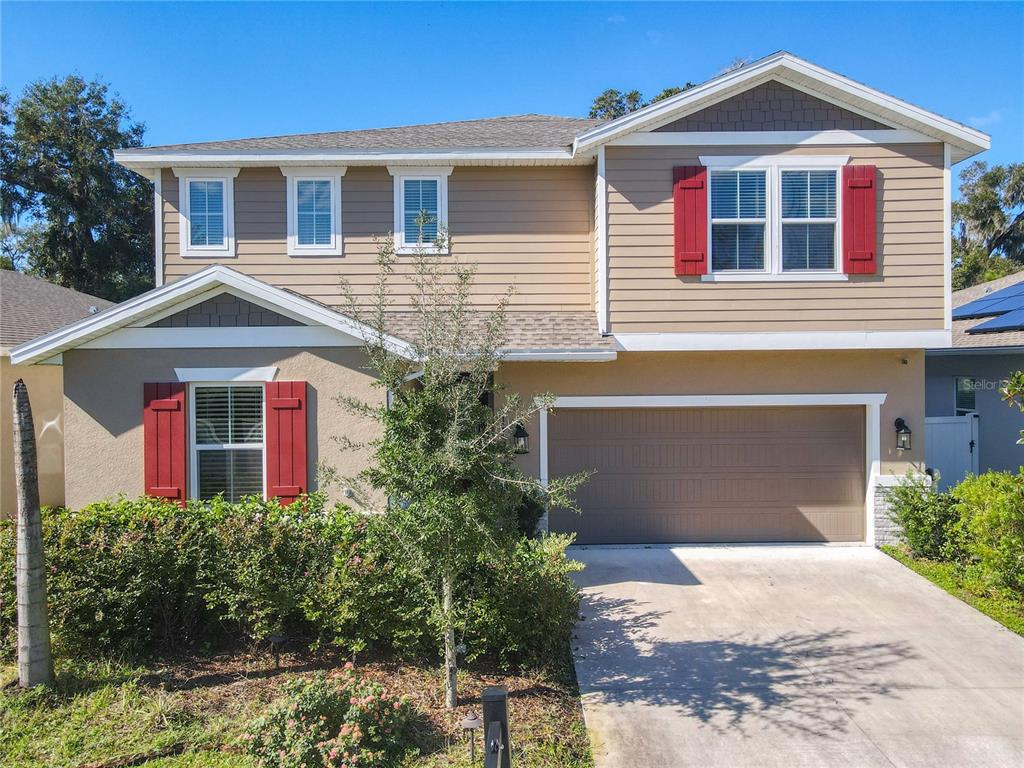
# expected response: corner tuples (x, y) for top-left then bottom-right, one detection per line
(572, 547), (1024, 768)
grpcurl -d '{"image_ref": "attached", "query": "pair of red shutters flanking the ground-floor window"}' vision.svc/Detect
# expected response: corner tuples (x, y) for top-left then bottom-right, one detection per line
(142, 381), (308, 506)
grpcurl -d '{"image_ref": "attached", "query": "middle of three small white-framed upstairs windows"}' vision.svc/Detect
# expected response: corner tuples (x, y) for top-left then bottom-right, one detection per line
(281, 167), (347, 256)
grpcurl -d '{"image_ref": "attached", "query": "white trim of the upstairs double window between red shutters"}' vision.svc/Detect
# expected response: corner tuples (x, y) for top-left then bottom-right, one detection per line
(700, 155), (850, 283)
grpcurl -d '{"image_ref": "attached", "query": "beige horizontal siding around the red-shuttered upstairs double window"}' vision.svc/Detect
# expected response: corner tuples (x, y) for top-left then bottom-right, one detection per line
(607, 143), (944, 333)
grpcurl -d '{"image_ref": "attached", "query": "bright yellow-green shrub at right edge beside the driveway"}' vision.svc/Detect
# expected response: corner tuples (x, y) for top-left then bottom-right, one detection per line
(952, 472), (1024, 592)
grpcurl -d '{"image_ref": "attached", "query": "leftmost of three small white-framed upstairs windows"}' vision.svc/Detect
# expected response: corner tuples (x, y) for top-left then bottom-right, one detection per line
(172, 168), (239, 258)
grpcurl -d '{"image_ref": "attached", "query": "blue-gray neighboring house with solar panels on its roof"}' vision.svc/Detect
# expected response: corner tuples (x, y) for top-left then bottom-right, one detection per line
(925, 271), (1024, 487)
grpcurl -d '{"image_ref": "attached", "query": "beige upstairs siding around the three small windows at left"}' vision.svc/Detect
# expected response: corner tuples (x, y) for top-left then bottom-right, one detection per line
(163, 166), (594, 311)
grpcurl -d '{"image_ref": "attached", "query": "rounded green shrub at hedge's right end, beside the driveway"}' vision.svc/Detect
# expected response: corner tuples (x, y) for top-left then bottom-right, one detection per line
(466, 535), (583, 668)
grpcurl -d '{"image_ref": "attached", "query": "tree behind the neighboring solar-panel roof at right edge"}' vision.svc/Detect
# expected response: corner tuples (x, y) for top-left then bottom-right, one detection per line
(952, 161), (1024, 291)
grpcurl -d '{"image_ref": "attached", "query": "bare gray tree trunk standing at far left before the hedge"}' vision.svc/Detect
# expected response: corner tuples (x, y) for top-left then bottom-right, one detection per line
(13, 379), (53, 688)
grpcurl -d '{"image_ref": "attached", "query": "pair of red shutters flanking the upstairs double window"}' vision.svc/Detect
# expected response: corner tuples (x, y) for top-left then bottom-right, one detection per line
(672, 165), (879, 275)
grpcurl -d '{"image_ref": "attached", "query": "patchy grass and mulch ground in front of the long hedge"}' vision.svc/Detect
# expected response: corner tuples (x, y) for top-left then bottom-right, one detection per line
(0, 654), (592, 768)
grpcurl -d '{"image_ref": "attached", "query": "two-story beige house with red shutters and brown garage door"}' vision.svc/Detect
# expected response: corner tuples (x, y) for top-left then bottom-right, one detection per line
(4, 53), (989, 543)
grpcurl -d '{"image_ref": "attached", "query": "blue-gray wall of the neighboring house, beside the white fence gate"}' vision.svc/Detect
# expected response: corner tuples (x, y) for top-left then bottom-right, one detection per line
(925, 353), (1024, 472)
